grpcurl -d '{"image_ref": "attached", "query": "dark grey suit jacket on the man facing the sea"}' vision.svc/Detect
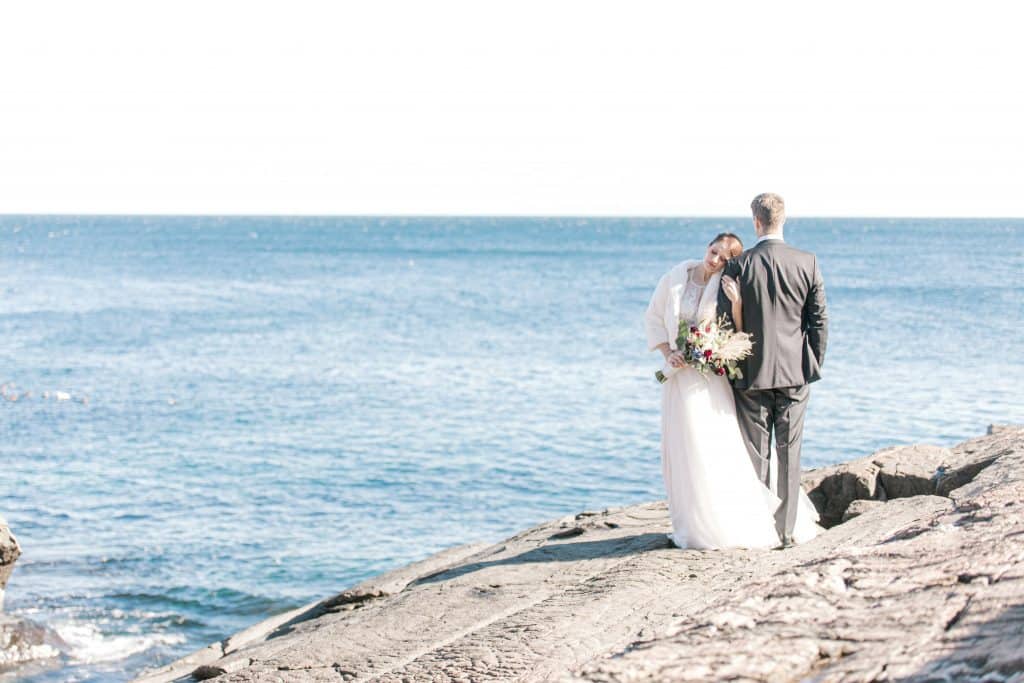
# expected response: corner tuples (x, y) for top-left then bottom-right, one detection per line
(718, 240), (828, 390)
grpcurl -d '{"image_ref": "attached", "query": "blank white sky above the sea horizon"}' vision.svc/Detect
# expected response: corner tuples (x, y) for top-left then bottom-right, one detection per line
(0, 0), (1024, 216)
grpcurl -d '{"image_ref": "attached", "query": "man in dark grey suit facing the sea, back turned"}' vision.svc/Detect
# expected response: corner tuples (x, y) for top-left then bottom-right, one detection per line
(718, 193), (828, 548)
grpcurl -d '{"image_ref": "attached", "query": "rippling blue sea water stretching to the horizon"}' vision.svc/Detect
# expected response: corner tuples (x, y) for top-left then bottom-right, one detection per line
(0, 216), (1024, 682)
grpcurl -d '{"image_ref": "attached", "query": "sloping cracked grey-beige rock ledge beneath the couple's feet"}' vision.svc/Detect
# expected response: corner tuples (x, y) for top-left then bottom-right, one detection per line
(139, 427), (1024, 683)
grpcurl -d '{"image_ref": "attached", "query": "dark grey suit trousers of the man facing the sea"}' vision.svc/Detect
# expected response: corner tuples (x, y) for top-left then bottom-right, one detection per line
(733, 384), (811, 539)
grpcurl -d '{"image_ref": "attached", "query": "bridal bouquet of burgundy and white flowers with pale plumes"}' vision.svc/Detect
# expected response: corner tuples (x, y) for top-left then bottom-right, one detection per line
(654, 315), (753, 384)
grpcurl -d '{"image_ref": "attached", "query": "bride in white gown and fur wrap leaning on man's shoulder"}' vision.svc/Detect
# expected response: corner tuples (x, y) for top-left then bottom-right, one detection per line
(645, 232), (819, 548)
